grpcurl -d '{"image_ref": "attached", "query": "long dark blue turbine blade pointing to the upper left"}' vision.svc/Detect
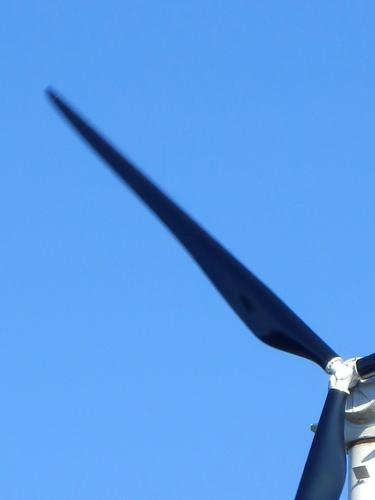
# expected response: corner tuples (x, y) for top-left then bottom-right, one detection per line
(47, 91), (337, 368)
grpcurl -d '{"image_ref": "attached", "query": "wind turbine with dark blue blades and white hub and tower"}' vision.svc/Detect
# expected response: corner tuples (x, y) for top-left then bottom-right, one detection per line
(47, 90), (375, 500)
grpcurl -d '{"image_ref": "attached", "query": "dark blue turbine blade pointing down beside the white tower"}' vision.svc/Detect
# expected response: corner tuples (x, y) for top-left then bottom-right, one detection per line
(296, 389), (347, 500)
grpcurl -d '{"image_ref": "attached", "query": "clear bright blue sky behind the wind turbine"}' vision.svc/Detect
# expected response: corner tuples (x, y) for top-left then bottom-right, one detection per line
(0, 0), (375, 500)
